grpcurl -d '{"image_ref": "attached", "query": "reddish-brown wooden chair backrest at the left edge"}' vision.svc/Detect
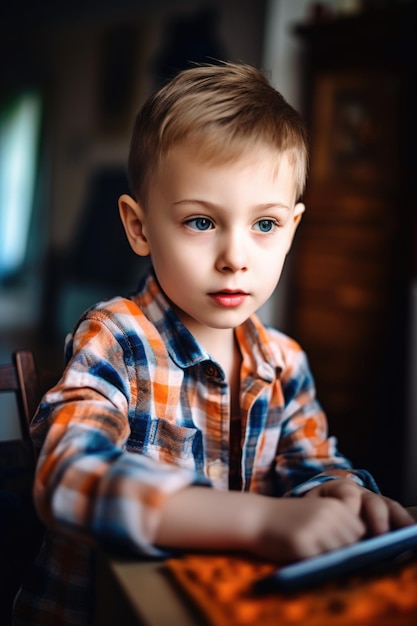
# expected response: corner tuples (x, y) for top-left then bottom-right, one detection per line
(0, 350), (42, 441)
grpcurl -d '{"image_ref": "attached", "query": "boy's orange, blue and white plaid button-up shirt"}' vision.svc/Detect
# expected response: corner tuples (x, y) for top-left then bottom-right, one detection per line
(15, 272), (377, 626)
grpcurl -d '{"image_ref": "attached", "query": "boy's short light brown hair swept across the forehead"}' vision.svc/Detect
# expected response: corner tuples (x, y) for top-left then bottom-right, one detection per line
(128, 63), (308, 204)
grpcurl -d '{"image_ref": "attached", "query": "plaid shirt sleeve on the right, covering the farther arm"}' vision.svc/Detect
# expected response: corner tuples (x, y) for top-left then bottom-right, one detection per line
(276, 350), (379, 496)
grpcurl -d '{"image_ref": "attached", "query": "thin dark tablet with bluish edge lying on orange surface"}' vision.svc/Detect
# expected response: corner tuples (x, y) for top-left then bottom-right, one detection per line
(254, 524), (417, 593)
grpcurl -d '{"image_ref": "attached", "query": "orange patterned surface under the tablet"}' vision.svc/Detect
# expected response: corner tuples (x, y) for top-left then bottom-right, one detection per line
(166, 555), (417, 626)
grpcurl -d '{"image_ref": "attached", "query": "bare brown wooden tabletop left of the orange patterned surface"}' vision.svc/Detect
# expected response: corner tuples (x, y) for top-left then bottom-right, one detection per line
(94, 506), (417, 626)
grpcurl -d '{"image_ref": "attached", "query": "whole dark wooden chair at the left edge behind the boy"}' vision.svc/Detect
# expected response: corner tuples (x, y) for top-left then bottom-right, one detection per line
(0, 350), (43, 626)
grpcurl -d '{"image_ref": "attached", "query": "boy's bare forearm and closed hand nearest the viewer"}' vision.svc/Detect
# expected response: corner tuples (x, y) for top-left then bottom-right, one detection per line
(155, 486), (366, 564)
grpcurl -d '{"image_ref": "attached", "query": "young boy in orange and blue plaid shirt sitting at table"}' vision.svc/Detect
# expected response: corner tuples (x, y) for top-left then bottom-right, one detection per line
(15, 64), (412, 626)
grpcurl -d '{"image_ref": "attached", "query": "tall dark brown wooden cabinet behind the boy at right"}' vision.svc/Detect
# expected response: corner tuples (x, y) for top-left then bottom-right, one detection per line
(290, 5), (417, 498)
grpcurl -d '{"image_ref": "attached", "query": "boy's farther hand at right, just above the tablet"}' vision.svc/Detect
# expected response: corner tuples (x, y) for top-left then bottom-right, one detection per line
(305, 478), (415, 535)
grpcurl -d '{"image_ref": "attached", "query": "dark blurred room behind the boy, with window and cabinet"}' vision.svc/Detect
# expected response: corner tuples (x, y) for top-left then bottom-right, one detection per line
(0, 0), (417, 504)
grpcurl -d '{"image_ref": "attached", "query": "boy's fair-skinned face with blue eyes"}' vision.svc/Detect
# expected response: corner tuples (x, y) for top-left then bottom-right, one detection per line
(121, 141), (304, 338)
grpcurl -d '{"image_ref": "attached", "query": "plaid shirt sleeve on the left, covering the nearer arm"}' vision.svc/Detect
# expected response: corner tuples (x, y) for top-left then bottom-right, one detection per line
(32, 306), (209, 556)
